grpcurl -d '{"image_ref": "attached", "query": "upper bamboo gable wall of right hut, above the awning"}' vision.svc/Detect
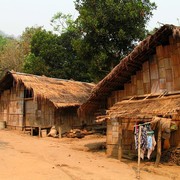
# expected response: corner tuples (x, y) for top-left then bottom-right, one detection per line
(107, 37), (180, 108)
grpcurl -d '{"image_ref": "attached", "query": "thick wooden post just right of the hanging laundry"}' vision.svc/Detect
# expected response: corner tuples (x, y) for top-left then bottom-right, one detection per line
(155, 120), (162, 167)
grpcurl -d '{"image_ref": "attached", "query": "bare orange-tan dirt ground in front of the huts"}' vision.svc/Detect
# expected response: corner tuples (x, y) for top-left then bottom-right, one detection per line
(0, 130), (180, 180)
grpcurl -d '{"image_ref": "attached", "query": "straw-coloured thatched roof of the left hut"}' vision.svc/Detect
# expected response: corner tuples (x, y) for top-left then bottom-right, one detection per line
(0, 71), (94, 107)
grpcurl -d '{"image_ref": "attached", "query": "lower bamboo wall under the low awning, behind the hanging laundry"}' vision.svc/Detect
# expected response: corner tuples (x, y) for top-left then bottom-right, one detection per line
(106, 115), (180, 158)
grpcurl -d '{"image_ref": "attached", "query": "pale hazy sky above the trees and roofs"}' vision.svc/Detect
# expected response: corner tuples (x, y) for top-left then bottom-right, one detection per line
(0, 0), (180, 36)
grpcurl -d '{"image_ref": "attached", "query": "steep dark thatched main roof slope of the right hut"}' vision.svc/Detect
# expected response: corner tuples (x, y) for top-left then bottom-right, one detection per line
(79, 25), (180, 113)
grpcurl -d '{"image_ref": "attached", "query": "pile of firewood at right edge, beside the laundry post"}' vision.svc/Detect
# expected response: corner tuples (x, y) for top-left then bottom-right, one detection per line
(161, 146), (180, 166)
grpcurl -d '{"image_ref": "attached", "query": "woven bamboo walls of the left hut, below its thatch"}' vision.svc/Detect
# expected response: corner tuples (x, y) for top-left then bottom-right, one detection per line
(0, 86), (81, 132)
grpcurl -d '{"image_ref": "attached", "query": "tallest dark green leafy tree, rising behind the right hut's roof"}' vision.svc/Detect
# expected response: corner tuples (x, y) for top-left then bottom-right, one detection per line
(74, 0), (156, 81)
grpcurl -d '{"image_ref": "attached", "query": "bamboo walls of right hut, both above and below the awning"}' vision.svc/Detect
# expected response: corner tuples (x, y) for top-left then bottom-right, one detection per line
(107, 37), (180, 158)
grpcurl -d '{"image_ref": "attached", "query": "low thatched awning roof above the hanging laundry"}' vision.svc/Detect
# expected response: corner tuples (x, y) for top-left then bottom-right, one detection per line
(107, 95), (180, 118)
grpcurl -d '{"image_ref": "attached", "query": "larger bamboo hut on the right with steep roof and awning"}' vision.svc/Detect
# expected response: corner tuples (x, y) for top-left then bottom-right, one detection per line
(78, 25), (180, 162)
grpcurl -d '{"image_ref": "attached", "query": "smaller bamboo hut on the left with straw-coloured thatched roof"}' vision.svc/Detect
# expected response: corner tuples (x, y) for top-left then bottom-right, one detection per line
(0, 71), (94, 133)
